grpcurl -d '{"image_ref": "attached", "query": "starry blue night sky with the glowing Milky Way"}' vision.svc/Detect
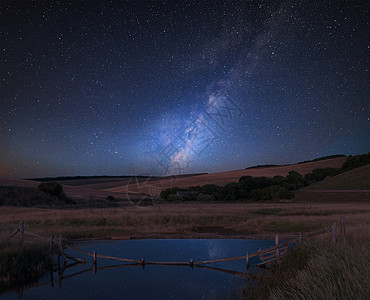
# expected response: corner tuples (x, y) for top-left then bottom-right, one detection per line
(0, 0), (370, 178)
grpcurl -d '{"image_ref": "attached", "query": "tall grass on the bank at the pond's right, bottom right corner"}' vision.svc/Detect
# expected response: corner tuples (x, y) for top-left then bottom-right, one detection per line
(243, 235), (370, 300)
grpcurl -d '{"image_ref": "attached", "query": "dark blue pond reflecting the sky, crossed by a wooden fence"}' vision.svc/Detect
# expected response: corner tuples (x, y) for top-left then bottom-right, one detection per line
(0, 239), (274, 299)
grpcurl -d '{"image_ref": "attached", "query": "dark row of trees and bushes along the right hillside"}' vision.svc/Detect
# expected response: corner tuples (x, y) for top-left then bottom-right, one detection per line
(160, 153), (370, 202)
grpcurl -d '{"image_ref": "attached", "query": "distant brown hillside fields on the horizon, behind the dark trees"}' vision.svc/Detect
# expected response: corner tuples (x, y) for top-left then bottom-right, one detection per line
(0, 157), (347, 200)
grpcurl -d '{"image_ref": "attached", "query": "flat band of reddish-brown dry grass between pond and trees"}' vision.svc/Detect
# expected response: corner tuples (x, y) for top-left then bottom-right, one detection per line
(0, 203), (370, 238)
